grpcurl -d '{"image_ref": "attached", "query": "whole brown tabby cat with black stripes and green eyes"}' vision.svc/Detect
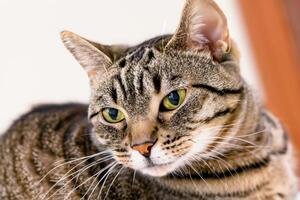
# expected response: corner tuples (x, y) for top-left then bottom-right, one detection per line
(0, 0), (297, 200)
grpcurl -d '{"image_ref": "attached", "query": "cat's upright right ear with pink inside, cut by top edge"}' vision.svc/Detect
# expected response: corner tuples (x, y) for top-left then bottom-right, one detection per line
(166, 0), (230, 60)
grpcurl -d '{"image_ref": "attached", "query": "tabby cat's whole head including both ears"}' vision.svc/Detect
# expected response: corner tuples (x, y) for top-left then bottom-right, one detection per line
(61, 0), (243, 176)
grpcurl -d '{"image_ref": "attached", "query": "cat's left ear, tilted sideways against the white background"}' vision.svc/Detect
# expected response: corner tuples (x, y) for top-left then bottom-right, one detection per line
(60, 31), (112, 80)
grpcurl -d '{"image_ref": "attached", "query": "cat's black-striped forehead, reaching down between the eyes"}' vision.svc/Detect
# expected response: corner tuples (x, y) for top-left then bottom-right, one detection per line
(93, 47), (226, 115)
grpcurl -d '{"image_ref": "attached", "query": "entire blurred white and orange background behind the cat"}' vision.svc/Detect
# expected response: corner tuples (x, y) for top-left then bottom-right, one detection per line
(0, 0), (300, 172)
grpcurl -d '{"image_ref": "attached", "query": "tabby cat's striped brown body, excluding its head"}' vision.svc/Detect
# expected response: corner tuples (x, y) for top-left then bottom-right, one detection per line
(0, 104), (297, 200)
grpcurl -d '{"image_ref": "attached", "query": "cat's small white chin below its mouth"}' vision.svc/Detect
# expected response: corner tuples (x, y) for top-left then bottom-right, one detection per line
(140, 164), (175, 177)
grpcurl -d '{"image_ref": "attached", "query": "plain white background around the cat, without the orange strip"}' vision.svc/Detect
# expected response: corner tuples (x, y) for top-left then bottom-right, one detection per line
(0, 0), (260, 132)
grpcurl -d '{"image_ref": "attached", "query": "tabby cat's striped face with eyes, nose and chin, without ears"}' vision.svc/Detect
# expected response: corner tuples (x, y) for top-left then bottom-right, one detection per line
(90, 48), (241, 176)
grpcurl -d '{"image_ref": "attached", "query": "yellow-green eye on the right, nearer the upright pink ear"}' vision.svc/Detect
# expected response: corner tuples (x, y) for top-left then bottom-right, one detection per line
(161, 89), (186, 111)
